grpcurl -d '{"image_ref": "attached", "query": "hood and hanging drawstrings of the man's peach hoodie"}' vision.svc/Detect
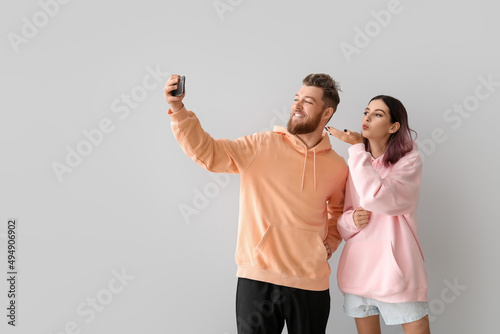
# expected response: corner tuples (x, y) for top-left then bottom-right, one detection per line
(274, 126), (332, 192)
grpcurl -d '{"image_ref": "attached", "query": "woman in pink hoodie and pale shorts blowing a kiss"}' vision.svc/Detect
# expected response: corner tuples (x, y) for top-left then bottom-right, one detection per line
(326, 95), (430, 334)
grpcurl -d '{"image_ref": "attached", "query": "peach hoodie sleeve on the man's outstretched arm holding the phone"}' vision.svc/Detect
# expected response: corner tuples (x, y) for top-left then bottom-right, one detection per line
(168, 107), (257, 173)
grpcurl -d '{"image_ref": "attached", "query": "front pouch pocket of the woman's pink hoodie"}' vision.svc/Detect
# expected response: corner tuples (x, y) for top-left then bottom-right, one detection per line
(337, 240), (406, 292)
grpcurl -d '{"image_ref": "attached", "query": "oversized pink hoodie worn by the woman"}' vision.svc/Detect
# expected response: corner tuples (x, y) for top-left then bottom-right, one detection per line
(337, 144), (427, 303)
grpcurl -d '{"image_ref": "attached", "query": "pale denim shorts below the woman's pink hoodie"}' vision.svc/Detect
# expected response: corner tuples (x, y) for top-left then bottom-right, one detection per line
(344, 293), (429, 325)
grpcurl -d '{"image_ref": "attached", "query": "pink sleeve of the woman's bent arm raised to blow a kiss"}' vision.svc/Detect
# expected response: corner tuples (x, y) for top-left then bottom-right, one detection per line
(348, 144), (422, 216)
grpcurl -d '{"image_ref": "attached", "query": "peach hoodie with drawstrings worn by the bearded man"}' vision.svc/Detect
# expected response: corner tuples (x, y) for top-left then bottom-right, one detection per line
(169, 108), (348, 291)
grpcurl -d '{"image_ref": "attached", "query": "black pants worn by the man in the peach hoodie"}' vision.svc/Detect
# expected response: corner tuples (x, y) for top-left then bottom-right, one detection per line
(236, 278), (330, 334)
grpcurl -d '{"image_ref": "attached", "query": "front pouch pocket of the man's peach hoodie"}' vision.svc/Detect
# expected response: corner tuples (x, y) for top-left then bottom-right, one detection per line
(253, 225), (330, 279)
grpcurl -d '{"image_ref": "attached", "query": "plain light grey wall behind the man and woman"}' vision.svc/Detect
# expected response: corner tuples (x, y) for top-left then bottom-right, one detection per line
(0, 0), (500, 334)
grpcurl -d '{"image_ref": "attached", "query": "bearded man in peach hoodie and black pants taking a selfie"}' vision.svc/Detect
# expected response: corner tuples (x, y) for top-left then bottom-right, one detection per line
(164, 74), (348, 334)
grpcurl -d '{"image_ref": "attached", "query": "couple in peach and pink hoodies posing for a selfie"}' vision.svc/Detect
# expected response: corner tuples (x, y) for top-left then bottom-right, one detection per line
(164, 74), (430, 334)
